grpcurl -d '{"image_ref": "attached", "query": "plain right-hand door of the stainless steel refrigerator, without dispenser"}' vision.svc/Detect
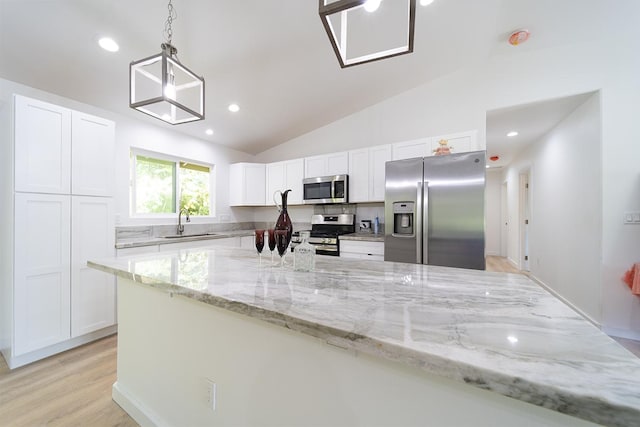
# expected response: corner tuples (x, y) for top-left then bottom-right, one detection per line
(423, 151), (486, 270)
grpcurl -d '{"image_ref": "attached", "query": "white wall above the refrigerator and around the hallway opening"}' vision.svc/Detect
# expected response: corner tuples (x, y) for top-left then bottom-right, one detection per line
(258, 7), (640, 339)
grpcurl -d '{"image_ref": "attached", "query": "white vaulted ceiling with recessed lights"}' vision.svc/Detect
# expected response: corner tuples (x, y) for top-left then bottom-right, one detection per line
(0, 0), (607, 154)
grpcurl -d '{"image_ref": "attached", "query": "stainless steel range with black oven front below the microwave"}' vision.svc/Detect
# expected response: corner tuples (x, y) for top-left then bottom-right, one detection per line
(291, 214), (356, 256)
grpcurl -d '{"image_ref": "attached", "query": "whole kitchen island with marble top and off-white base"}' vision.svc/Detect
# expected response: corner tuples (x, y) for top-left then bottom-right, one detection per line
(89, 248), (640, 426)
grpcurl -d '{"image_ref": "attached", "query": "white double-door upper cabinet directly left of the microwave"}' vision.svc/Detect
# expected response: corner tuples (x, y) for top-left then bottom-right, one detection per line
(265, 159), (304, 206)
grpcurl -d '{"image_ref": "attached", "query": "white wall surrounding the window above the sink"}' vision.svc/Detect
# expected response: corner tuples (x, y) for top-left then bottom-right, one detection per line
(0, 79), (253, 229)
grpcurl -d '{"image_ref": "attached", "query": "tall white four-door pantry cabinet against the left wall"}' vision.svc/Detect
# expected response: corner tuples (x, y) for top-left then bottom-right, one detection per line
(2, 95), (116, 368)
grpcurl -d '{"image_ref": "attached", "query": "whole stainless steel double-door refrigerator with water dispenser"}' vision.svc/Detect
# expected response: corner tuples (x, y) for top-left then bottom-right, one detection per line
(384, 151), (486, 270)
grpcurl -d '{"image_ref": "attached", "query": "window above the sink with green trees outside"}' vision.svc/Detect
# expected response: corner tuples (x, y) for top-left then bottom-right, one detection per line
(130, 152), (213, 216)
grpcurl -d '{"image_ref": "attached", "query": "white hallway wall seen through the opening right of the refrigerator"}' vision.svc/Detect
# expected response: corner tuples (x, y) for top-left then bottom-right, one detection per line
(505, 94), (602, 322)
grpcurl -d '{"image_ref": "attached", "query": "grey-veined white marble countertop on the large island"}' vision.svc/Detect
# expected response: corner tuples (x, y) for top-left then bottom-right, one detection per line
(88, 247), (640, 426)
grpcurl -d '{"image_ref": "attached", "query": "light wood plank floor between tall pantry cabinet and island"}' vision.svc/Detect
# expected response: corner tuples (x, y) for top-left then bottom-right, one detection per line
(0, 335), (138, 427)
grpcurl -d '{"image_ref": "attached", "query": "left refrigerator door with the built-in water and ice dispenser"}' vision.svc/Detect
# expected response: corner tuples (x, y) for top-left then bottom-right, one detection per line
(384, 157), (423, 264)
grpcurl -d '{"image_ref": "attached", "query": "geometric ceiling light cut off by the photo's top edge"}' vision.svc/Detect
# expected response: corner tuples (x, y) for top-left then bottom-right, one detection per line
(319, 0), (416, 68)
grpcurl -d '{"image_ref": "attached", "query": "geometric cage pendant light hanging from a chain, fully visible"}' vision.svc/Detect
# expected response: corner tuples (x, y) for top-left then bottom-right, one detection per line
(129, 0), (204, 125)
